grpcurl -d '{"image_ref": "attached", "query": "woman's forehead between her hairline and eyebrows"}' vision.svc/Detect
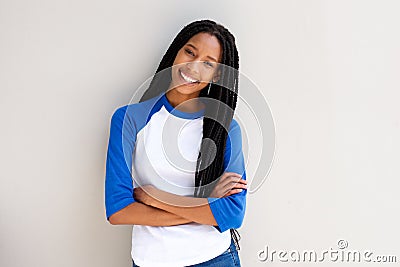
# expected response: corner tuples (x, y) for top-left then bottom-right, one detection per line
(186, 32), (222, 61)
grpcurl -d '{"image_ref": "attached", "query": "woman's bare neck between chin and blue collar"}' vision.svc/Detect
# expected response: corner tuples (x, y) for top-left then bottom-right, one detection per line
(165, 89), (205, 112)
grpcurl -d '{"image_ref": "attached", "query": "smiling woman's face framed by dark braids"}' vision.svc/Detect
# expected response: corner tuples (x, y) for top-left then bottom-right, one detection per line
(170, 33), (222, 95)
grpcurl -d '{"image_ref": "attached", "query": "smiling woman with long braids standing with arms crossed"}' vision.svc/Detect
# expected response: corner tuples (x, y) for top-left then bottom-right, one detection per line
(105, 20), (247, 267)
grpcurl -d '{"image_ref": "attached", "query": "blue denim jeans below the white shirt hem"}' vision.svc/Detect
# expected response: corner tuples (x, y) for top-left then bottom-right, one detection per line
(132, 239), (240, 267)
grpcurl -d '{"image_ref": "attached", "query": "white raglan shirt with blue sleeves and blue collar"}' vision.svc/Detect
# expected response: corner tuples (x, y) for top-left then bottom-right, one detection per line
(105, 93), (247, 267)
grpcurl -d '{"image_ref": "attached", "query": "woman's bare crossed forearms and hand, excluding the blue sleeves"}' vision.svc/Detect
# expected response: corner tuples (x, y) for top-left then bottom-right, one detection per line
(109, 172), (247, 226)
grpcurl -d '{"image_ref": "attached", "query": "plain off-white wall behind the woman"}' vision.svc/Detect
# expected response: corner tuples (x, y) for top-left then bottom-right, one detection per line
(0, 0), (400, 267)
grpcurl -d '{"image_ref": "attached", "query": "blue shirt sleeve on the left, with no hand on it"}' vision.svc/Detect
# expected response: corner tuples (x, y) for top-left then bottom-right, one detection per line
(105, 106), (136, 220)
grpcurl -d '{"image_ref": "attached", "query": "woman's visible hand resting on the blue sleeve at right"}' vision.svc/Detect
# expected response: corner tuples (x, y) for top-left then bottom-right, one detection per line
(209, 172), (247, 198)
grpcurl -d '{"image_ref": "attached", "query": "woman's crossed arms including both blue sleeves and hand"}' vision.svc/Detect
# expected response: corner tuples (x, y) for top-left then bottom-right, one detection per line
(105, 106), (247, 229)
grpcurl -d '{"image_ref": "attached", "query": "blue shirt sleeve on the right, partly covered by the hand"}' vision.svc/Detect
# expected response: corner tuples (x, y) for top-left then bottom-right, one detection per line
(207, 119), (247, 233)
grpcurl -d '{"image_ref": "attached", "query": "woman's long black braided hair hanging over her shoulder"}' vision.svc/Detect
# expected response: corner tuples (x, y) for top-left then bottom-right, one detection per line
(139, 20), (240, 249)
